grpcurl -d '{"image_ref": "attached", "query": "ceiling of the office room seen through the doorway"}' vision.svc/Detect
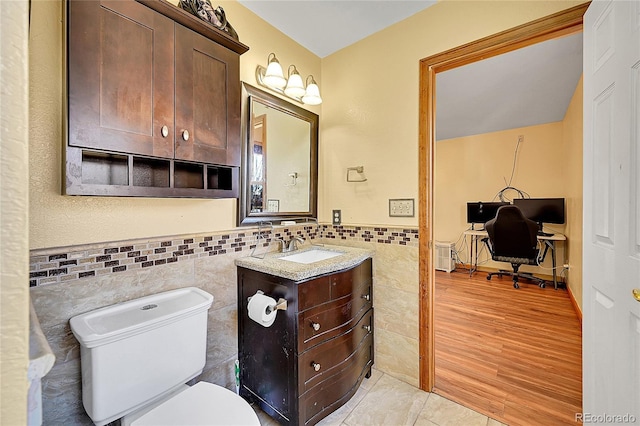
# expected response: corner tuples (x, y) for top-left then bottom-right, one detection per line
(436, 33), (582, 140)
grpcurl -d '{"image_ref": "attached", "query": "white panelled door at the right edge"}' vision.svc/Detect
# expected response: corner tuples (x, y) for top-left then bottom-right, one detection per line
(583, 0), (640, 424)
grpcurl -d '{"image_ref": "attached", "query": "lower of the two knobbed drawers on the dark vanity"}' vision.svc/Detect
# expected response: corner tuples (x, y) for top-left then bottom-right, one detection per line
(298, 308), (373, 393)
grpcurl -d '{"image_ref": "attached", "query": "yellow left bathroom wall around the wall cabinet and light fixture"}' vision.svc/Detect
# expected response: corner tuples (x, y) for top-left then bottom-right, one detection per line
(29, 1), (322, 249)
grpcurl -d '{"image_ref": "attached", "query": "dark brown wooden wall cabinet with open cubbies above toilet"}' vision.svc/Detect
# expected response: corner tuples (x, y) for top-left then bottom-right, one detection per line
(65, 0), (248, 198)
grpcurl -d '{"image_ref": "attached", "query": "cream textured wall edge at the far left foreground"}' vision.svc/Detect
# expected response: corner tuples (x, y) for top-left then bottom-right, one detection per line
(0, 1), (29, 425)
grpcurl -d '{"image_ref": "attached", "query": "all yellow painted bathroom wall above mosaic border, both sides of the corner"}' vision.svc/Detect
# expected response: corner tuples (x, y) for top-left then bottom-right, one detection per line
(30, 1), (580, 248)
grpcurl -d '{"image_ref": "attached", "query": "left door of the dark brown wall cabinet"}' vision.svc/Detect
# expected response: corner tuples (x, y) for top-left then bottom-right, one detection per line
(68, 0), (174, 158)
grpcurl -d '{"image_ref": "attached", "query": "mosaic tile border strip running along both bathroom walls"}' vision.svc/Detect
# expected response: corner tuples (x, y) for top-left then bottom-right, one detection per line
(29, 224), (418, 287)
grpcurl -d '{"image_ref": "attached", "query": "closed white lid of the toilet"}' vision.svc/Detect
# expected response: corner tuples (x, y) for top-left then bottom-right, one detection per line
(131, 382), (260, 426)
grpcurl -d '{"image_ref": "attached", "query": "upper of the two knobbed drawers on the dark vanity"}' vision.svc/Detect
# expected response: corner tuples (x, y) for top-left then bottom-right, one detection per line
(298, 284), (372, 353)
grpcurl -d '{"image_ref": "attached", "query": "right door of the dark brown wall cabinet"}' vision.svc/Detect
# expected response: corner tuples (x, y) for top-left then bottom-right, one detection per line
(175, 24), (240, 166)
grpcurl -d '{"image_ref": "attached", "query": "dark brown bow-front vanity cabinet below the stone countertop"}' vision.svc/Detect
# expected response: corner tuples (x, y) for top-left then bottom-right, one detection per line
(238, 258), (373, 425)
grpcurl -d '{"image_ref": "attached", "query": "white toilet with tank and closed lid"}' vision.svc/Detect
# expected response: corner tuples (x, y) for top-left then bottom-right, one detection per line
(70, 287), (260, 426)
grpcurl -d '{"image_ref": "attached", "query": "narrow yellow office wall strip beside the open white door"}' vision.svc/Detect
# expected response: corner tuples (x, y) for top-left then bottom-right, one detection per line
(562, 79), (583, 309)
